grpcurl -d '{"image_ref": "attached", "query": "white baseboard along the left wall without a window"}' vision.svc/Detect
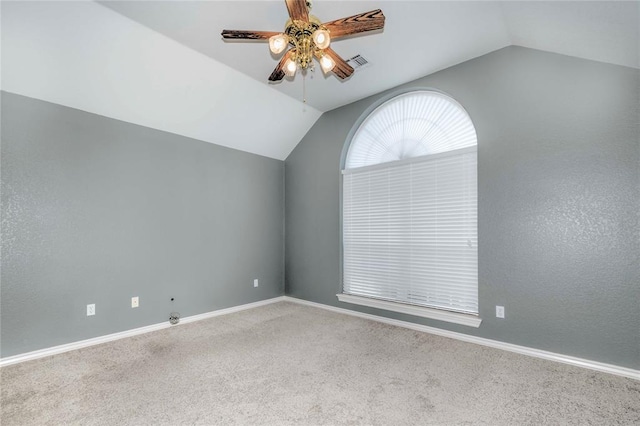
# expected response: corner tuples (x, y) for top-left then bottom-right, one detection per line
(0, 296), (284, 367)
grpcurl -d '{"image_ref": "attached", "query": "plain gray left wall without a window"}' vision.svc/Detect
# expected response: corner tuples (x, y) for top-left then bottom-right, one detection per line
(0, 92), (284, 357)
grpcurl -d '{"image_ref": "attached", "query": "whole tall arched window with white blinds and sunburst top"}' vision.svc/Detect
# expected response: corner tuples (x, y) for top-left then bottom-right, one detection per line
(338, 90), (479, 326)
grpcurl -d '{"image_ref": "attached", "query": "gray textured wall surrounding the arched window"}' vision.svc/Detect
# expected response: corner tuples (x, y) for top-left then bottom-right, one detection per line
(285, 47), (640, 368)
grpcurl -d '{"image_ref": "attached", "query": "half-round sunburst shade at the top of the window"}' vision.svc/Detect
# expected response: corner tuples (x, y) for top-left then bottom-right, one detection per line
(345, 90), (477, 169)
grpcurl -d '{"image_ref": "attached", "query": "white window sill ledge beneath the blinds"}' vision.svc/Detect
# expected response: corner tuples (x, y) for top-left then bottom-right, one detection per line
(336, 293), (482, 328)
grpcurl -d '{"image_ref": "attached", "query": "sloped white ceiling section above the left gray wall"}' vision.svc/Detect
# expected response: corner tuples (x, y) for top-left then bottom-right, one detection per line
(1, 2), (322, 160)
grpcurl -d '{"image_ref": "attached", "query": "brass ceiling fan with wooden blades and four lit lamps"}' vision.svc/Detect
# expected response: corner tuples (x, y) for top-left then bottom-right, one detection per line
(222, 0), (384, 82)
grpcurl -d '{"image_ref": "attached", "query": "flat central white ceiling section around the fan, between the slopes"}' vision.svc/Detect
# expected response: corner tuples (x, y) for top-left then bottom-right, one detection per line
(97, 0), (511, 111)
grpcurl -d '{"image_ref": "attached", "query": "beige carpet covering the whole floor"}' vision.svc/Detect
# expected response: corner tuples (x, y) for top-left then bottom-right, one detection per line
(1, 302), (640, 426)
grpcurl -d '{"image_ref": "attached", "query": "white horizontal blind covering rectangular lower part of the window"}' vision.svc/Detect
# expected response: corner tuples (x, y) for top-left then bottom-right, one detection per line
(343, 146), (478, 313)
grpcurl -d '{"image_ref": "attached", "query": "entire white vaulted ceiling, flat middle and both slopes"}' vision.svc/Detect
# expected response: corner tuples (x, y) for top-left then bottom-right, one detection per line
(2, 0), (640, 159)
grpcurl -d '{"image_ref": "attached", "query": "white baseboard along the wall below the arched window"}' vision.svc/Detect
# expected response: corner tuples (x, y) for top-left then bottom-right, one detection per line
(282, 296), (640, 380)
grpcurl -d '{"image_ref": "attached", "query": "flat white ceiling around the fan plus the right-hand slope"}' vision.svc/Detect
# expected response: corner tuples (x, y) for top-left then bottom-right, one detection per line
(104, 0), (639, 111)
